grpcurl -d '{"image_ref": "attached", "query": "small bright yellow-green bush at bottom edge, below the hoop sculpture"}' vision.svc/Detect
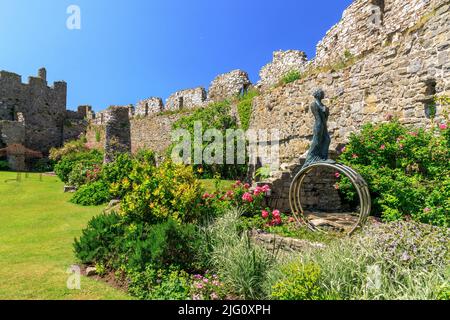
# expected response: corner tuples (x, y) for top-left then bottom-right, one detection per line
(272, 263), (326, 300)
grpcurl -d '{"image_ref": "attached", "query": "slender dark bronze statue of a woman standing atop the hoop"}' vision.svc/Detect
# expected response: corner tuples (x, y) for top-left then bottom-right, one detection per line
(303, 89), (334, 168)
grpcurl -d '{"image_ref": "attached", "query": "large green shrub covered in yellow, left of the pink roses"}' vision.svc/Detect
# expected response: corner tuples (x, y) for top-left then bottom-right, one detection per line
(118, 161), (205, 223)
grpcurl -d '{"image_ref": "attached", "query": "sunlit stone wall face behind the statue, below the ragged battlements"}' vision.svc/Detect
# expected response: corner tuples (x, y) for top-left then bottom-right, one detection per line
(251, 0), (450, 162)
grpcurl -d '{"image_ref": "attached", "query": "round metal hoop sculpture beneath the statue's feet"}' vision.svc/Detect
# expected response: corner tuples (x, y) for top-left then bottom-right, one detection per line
(289, 162), (372, 235)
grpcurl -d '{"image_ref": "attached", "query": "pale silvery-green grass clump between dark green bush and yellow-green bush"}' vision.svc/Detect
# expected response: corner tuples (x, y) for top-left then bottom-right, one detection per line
(208, 209), (275, 300)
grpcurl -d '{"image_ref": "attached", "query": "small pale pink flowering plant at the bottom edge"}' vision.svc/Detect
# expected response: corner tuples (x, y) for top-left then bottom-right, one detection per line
(191, 273), (226, 300)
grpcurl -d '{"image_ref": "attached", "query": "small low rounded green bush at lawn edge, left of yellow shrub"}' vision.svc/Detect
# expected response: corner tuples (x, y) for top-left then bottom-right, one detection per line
(70, 181), (111, 206)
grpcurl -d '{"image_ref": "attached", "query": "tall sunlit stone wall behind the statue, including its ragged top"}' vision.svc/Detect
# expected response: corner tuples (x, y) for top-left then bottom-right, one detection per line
(251, 0), (450, 210)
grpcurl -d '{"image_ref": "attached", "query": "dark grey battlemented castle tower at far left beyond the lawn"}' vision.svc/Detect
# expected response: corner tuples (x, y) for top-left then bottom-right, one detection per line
(0, 68), (87, 153)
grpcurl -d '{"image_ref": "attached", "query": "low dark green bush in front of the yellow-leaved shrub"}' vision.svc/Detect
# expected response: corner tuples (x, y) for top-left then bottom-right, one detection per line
(74, 213), (201, 272)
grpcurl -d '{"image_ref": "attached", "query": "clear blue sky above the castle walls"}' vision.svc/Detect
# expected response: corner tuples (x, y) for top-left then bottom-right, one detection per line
(0, 0), (352, 111)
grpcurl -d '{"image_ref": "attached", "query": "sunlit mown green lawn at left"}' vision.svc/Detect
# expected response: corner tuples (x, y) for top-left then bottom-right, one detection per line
(0, 172), (129, 300)
